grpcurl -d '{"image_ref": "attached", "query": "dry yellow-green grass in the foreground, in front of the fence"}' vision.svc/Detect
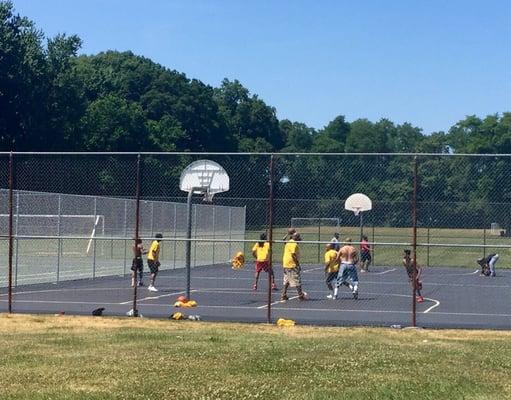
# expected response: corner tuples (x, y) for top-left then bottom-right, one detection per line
(0, 314), (511, 400)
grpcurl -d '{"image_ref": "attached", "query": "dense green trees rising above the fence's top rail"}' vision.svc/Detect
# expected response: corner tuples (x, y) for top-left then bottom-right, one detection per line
(0, 1), (511, 153)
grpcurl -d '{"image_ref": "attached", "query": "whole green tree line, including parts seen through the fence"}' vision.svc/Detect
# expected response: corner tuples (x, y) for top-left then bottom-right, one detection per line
(0, 1), (511, 230)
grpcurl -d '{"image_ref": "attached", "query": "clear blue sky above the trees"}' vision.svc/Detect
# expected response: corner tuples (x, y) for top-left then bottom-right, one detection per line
(14, 0), (511, 134)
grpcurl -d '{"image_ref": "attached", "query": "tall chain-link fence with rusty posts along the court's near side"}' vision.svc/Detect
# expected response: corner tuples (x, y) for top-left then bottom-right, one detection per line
(0, 153), (511, 328)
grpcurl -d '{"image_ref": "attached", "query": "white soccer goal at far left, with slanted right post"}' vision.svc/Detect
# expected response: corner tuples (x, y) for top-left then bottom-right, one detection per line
(0, 214), (105, 254)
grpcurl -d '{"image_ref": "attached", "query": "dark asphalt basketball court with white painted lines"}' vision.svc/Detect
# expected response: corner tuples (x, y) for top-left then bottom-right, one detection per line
(0, 264), (511, 329)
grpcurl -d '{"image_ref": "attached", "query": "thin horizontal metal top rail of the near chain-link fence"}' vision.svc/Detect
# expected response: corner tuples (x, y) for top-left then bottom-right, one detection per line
(0, 151), (511, 157)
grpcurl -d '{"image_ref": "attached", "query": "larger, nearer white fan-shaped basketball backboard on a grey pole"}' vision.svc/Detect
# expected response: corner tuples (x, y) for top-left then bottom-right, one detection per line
(179, 160), (229, 195)
